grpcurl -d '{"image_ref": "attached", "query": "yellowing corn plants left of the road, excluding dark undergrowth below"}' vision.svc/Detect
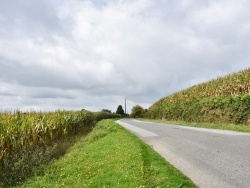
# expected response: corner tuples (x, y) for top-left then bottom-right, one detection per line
(0, 111), (118, 170)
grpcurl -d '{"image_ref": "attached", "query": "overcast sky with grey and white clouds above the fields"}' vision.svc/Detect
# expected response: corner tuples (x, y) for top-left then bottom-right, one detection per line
(0, 0), (250, 112)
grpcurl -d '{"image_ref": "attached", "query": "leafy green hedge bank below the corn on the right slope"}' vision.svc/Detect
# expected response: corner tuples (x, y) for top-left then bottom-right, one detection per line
(146, 95), (250, 125)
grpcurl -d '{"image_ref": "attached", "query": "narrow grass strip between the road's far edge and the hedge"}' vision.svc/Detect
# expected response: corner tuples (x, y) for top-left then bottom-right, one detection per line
(138, 118), (250, 133)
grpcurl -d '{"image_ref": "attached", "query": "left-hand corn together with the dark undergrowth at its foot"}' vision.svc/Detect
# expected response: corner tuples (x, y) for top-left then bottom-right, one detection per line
(0, 110), (120, 187)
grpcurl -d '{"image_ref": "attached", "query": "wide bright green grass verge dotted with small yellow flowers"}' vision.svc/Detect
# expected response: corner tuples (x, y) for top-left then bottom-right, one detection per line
(18, 120), (196, 188)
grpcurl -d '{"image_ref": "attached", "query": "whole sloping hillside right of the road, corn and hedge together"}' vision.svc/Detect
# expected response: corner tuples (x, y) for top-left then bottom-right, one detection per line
(146, 68), (250, 125)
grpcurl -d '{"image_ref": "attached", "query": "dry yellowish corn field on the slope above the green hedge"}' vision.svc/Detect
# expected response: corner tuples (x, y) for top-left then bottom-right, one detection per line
(149, 68), (250, 110)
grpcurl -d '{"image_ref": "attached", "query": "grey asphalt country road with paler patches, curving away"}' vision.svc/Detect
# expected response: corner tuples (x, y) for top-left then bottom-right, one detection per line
(117, 119), (250, 188)
